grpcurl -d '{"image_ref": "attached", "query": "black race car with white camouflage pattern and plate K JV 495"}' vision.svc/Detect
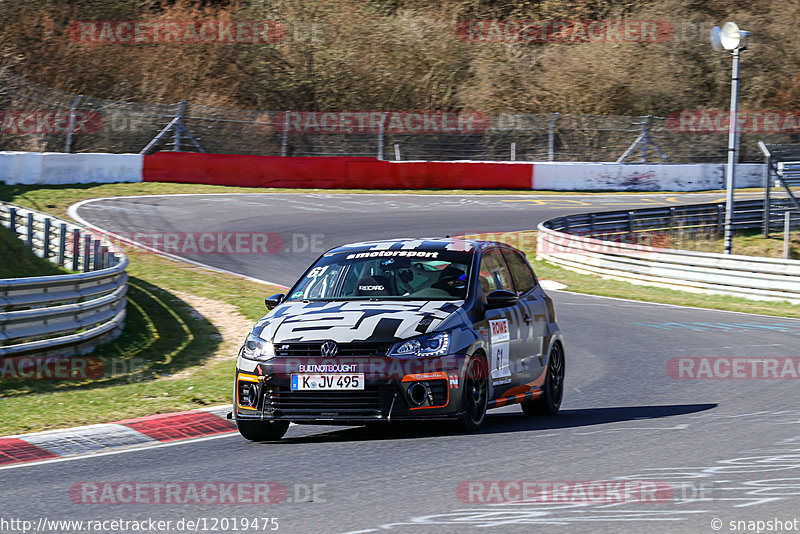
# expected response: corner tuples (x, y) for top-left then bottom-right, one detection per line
(233, 238), (565, 441)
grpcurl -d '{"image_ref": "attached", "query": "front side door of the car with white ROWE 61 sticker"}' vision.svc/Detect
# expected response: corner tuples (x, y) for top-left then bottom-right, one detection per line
(478, 247), (522, 392)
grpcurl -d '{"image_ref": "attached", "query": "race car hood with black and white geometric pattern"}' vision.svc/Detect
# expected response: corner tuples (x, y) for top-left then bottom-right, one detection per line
(253, 301), (463, 343)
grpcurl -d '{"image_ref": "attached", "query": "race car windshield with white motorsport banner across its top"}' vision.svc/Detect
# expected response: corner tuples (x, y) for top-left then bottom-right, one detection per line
(287, 251), (472, 301)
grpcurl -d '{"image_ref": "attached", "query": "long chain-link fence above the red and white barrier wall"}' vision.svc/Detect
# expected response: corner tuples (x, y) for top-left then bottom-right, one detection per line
(0, 69), (800, 163)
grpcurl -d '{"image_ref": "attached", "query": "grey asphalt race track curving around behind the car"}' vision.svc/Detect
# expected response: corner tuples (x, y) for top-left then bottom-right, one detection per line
(0, 194), (800, 533)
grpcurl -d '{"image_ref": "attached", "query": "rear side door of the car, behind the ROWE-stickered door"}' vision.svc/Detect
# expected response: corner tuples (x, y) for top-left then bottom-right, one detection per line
(502, 247), (548, 381)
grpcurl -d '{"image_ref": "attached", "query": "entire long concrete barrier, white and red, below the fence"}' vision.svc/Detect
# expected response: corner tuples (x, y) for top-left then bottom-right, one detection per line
(0, 152), (763, 191)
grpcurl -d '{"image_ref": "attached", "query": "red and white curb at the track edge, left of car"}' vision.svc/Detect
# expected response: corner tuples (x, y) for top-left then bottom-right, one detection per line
(0, 405), (236, 466)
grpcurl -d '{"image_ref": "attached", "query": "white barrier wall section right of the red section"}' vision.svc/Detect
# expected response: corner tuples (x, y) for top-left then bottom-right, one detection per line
(531, 162), (764, 191)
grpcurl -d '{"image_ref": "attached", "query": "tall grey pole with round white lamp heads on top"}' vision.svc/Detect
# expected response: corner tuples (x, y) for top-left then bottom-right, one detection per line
(711, 22), (750, 254)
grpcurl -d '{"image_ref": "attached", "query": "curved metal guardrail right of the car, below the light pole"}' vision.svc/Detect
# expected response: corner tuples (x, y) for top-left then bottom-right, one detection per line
(537, 200), (800, 303)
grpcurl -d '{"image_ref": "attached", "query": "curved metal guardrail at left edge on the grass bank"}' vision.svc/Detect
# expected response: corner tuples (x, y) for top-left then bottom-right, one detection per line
(0, 203), (128, 356)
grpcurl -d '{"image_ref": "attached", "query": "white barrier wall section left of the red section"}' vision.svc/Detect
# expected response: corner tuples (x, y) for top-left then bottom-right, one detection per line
(0, 152), (144, 185)
